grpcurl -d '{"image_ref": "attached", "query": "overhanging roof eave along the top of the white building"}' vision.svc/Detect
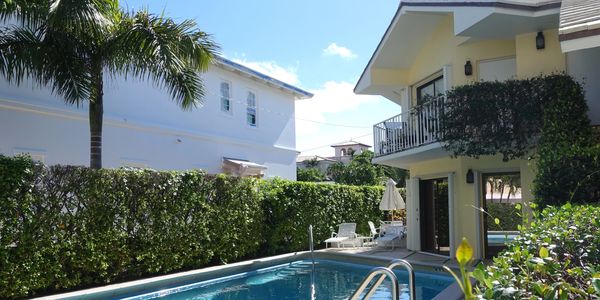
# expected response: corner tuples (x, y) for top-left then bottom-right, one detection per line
(214, 56), (313, 99)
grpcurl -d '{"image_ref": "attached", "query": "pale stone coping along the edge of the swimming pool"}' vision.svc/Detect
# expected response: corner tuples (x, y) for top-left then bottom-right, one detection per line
(35, 251), (463, 300)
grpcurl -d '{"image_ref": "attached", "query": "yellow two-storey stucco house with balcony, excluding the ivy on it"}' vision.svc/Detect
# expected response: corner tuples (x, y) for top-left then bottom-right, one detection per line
(355, 0), (600, 258)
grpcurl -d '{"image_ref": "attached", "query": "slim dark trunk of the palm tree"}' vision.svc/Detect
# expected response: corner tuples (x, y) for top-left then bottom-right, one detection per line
(89, 63), (104, 169)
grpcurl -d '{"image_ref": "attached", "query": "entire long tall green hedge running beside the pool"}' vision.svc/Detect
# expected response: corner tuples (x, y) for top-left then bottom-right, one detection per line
(0, 156), (382, 298)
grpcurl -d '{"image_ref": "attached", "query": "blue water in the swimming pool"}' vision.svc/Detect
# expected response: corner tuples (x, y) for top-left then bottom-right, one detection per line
(122, 260), (453, 300)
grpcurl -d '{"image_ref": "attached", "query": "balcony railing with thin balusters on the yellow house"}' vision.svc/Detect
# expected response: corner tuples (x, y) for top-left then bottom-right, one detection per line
(373, 97), (445, 157)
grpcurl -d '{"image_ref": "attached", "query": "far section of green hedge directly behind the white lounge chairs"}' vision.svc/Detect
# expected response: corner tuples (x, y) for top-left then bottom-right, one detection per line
(261, 179), (383, 254)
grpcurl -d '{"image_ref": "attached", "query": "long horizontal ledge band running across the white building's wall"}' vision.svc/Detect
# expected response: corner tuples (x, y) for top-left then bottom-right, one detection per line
(0, 98), (298, 152)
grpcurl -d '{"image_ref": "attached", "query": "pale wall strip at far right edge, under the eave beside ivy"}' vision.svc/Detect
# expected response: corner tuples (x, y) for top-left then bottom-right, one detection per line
(567, 48), (600, 125)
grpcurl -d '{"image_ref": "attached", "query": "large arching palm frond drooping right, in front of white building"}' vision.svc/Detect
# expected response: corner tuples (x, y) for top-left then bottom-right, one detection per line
(107, 11), (219, 109)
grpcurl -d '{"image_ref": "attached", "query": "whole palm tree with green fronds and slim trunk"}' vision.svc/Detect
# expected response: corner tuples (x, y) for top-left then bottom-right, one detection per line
(0, 0), (218, 169)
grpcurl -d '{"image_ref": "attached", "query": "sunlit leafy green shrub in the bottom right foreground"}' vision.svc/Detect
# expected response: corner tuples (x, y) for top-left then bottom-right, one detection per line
(473, 204), (600, 299)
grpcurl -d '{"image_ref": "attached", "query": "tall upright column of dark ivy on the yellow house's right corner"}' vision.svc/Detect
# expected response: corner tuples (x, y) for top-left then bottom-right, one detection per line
(534, 76), (600, 207)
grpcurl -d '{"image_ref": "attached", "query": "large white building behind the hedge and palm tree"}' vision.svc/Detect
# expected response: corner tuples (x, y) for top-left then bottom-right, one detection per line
(0, 58), (312, 179)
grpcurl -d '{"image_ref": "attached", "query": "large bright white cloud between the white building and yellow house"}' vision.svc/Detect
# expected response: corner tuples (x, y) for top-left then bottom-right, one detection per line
(296, 81), (379, 136)
